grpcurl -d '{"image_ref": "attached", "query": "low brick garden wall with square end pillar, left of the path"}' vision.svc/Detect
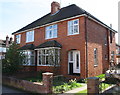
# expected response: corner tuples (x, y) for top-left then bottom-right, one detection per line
(2, 73), (53, 93)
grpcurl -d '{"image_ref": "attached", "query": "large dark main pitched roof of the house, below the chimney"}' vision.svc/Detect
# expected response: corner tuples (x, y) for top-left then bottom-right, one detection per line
(12, 4), (116, 34)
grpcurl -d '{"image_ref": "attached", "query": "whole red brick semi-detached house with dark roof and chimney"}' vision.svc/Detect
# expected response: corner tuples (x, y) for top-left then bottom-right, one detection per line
(12, 2), (116, 78)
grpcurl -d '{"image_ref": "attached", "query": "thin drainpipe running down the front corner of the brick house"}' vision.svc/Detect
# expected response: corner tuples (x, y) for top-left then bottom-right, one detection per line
(85, 13), (88, 77)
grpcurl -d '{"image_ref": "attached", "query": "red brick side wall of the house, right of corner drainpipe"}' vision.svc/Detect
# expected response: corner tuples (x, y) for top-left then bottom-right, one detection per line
(87, 19), (108, 77)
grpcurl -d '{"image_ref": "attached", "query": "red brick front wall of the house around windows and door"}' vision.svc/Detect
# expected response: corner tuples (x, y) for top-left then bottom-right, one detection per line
(14, 17), (86, 78)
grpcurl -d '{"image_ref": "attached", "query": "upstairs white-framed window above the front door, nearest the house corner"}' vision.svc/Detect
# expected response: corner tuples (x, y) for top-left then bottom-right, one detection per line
(68, 19), (79, 35)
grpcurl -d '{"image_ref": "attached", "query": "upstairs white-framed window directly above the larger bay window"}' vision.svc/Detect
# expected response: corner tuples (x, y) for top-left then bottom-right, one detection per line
(45, 24), (57, 39)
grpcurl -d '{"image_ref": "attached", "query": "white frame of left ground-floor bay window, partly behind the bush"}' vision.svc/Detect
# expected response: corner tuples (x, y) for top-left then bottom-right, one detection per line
(23, 50), (35, 66)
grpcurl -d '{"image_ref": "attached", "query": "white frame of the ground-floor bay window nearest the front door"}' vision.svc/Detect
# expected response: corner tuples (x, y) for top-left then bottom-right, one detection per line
(36, 47), (61, 66)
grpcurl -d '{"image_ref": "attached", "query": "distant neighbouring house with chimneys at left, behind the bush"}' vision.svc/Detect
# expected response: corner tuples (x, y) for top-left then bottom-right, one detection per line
(0, 36), (12, 60)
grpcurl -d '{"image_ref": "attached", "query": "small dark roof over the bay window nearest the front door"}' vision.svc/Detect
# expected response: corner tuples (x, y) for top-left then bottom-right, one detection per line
(35, 40), (62, 49)
